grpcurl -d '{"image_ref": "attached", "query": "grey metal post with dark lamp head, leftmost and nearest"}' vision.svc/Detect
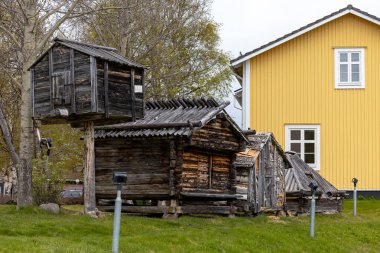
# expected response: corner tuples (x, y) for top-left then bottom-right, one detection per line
(112, 172), (128, 253)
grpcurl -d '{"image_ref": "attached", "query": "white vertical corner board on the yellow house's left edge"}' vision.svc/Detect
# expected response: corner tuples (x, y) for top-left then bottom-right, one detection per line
(242, 60), (251, 130)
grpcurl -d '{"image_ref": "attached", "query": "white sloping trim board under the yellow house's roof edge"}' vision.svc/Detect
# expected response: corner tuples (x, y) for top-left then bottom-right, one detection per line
(231, 9), (380, 67)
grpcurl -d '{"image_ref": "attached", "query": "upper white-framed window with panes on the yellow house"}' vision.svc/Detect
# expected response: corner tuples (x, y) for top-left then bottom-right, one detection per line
(335, 48), (365, 89)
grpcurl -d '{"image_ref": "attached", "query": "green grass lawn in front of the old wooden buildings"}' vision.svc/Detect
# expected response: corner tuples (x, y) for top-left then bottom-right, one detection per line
(0, 200), (380, 253)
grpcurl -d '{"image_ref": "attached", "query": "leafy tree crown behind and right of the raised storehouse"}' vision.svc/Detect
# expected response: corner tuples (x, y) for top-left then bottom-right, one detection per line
(85, 0), (231, 98)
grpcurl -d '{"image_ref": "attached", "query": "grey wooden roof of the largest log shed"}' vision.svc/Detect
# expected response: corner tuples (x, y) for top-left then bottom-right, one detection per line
(95, 98), (248, 142)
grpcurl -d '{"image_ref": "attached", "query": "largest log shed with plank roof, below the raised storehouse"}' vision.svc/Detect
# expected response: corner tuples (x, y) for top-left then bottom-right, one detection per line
(95, 99), (248, 215)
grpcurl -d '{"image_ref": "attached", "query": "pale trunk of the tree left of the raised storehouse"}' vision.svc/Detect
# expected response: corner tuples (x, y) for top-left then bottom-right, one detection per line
(17, 1), (37, 208)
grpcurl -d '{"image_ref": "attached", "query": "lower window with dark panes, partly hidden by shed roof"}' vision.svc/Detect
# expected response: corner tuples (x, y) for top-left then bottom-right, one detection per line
(285, 125), (320, 169)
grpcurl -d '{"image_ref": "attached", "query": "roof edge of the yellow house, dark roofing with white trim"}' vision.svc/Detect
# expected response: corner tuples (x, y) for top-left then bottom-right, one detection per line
(231, 5), (380, 68)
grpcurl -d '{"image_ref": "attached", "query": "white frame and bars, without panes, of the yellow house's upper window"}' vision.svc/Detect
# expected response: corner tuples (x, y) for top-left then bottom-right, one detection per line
(334, 48), (365, 89)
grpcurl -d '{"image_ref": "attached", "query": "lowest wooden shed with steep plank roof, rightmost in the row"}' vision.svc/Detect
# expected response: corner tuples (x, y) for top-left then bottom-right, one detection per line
(285, 152), (345, 213)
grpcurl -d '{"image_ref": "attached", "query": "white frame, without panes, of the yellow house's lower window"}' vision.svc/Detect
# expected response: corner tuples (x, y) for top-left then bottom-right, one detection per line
(285, 124), (321, 170)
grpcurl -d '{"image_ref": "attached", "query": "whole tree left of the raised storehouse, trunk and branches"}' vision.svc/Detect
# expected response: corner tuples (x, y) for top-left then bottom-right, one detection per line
(0, 0), (84, 207)
